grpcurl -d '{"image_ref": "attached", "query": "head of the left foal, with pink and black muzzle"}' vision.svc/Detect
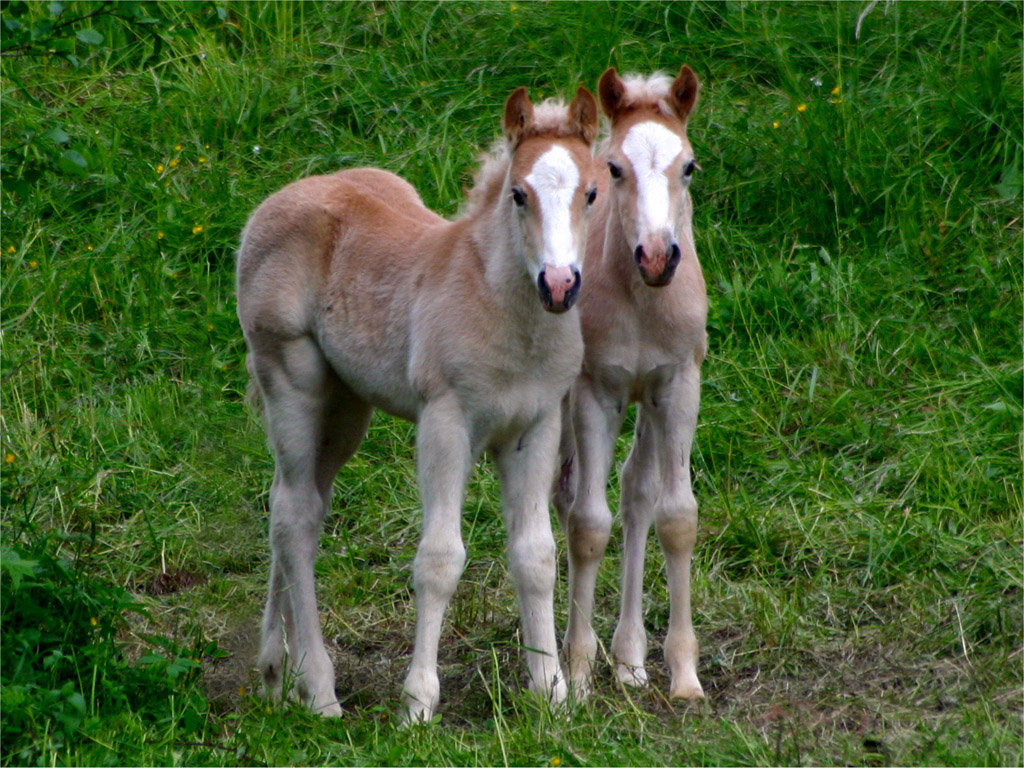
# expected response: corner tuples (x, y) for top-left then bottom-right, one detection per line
(501, 88), (598, 312)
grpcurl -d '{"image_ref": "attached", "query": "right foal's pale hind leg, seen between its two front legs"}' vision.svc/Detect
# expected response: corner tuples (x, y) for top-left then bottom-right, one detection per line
(611, 403), (659, 686)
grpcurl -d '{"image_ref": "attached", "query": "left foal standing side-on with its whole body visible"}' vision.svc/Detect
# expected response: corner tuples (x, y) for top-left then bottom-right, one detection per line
(238, 88), (598, 720)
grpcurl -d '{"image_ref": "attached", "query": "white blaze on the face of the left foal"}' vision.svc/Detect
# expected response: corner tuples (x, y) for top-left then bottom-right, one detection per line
(523, 146), (580, 266)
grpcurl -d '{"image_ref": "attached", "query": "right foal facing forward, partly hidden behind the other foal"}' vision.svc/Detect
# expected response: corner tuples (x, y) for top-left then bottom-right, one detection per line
(555, 67), (708, 698)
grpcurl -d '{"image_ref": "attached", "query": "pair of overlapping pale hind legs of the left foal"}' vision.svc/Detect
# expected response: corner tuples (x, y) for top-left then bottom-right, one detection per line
(254, 338), (371, 715)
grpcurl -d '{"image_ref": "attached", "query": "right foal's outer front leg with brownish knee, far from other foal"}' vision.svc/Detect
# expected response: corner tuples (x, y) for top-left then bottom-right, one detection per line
(655, 365), (703, 699)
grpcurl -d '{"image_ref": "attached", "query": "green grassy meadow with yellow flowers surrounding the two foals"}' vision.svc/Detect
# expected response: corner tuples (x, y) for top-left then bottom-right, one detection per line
(0, 0), (1024, 766)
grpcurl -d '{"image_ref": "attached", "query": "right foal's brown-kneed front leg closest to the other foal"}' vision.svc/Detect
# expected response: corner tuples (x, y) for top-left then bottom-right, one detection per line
(562, 377), (626, 698)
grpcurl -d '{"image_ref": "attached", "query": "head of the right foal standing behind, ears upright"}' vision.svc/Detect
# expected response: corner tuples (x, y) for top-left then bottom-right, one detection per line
(598, 65), (699, 286)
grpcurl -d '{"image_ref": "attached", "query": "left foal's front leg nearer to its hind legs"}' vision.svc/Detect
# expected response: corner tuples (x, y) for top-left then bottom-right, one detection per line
(402, 397), (473, 722)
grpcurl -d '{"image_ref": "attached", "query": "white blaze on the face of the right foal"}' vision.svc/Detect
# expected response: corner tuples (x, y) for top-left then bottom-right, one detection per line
(623, 123), (683, 234)
